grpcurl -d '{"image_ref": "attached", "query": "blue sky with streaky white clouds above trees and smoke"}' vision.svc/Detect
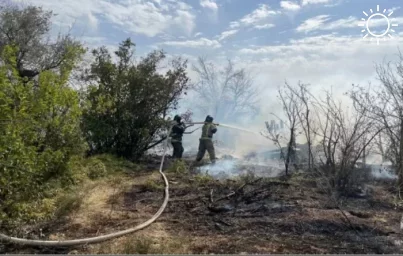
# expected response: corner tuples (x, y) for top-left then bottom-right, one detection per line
(7, 0), (403, 152)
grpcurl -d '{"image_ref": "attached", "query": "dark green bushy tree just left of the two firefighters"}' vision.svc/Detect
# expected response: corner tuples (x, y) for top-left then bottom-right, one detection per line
(83, 39), (189, 159)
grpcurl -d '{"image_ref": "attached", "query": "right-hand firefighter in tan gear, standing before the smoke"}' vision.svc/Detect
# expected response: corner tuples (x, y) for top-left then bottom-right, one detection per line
(196, 116), (217, 163)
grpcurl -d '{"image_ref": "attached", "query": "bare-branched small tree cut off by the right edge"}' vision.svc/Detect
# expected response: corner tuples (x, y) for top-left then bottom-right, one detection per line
(350, 53), (403, 190)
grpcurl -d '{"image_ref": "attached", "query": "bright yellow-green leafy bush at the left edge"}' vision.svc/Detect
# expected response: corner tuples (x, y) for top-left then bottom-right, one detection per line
(0, 46), (85, 226)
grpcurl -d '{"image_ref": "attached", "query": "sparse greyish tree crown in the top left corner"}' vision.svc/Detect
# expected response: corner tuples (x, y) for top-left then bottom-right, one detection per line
(0, 5), (81, 79)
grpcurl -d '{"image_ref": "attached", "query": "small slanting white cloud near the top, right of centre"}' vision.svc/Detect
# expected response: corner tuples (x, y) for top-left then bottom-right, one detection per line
(230, 4), (280, 29)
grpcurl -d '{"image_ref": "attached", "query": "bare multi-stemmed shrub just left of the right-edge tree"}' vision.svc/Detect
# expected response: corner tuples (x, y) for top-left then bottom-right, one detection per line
(317, 93), (381, 192)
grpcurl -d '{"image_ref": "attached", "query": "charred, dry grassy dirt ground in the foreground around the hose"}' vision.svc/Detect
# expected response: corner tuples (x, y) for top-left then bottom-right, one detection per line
(2, 156), (403, 254)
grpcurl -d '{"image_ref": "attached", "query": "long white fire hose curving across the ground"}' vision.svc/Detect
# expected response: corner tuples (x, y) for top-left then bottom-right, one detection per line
(0, 128), (172, 247)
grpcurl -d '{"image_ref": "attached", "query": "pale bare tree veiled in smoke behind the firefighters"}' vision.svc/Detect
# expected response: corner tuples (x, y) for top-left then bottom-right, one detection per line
(192, 57), (259, 147)
